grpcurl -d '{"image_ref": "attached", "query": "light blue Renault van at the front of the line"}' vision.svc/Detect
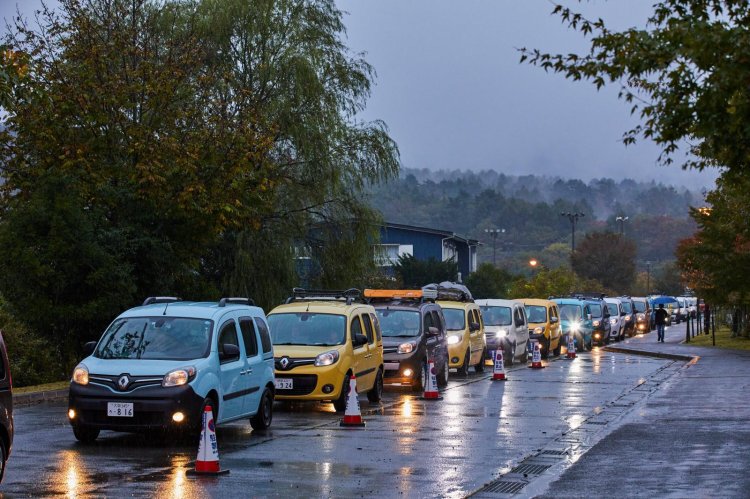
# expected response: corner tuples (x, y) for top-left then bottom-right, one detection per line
(68, 297), (274, 442)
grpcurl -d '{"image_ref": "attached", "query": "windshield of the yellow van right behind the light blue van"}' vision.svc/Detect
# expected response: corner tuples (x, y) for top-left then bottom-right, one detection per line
(268, 312), (346, 346)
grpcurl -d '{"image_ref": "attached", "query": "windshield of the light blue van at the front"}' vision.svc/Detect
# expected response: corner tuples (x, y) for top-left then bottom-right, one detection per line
(94, 317), (213, 360)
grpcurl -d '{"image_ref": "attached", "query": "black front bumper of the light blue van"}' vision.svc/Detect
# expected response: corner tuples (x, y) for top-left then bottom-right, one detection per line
(68, 383), (204, 432)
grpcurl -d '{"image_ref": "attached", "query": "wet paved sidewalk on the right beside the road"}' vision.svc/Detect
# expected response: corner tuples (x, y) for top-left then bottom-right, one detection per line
(540, 324), (750, 498)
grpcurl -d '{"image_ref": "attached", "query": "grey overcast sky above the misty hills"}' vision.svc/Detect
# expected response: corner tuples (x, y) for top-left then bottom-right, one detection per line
(0, 0), (716, 189)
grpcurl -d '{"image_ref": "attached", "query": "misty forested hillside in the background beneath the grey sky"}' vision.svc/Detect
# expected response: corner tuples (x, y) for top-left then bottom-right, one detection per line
(370, 169), (702, 262)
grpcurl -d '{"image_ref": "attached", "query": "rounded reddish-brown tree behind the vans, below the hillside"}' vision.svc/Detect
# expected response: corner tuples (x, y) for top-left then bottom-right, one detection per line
(571, 232), (635, 294)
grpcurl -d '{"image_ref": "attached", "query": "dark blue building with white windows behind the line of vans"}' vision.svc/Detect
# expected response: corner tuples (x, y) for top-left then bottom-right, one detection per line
(374, 223), (480, 279)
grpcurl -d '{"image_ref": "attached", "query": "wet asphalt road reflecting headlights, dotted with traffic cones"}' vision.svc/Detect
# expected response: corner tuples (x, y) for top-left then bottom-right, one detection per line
(2, 326), (684, 497)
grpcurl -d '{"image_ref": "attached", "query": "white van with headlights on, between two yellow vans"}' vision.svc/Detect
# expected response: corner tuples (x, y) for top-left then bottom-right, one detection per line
(475, 299), (529, 365)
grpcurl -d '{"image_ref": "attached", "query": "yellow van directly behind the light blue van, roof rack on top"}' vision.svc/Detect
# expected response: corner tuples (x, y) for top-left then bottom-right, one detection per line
(268, 288), (383, 411)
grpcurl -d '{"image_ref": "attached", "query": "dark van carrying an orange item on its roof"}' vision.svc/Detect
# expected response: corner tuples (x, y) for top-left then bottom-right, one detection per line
(365, 290), (448, 391)
